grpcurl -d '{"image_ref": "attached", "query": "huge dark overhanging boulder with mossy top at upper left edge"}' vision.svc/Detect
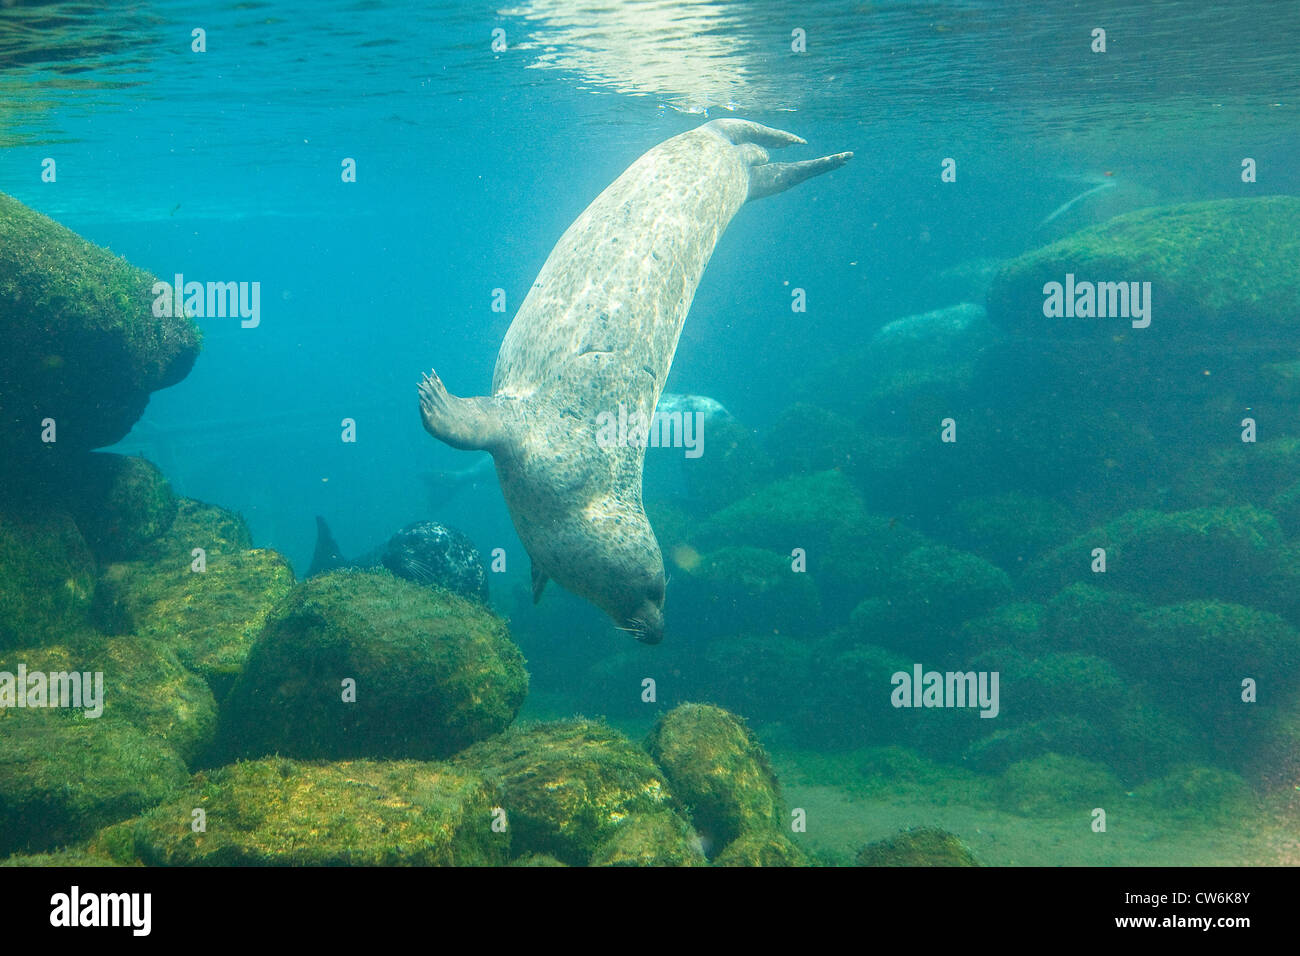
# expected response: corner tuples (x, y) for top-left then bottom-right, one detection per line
(0, 194), (200, 472)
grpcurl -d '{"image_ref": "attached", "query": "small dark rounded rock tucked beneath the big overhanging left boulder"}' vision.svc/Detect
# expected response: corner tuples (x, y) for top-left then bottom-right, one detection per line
(62, 453), (177, 562)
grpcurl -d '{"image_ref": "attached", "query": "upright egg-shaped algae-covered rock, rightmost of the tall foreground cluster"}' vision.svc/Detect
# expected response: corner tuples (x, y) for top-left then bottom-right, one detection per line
(647, 704), (785, 849)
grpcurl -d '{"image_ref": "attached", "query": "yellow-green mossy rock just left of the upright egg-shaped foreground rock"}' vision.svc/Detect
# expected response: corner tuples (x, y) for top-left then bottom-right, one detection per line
(452, 721), (676, 866)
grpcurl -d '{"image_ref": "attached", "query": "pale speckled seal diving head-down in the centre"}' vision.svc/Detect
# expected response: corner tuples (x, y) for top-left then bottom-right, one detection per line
(420, 118), (853, 644)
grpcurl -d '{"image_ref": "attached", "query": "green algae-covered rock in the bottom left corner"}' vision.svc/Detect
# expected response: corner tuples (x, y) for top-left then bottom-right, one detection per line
(0, 708), (189, 853)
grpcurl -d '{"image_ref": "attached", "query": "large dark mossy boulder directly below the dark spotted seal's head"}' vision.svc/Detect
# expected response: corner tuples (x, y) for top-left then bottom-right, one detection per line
(221, 571), (528, 760)
